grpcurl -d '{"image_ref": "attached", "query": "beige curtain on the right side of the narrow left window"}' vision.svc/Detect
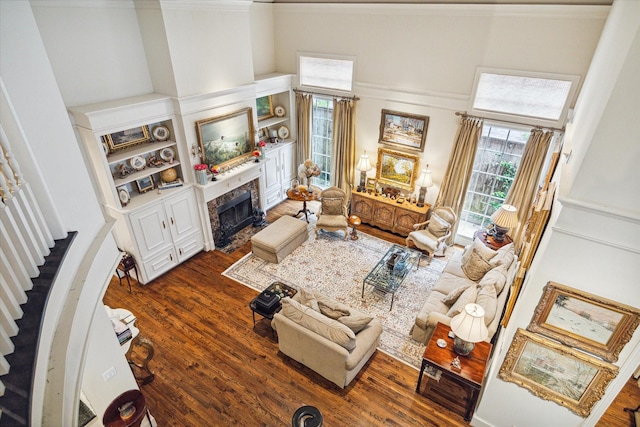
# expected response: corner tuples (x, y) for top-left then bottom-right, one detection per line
(331, 98), (356, 199)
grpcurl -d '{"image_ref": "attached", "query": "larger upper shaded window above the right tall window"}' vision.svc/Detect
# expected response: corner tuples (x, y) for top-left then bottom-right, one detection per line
(471, 69), (579, 127)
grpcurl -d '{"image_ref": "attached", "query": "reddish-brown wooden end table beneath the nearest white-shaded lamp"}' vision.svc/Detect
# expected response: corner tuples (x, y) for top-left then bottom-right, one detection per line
(416, 322), (491, 421)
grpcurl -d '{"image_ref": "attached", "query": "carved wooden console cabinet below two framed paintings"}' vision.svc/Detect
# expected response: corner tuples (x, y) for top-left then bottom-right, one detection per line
(351, 191), (431, 236)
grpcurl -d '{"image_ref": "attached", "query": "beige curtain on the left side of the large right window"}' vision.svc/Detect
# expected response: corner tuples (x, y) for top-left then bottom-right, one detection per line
(435, 117), (483, 245)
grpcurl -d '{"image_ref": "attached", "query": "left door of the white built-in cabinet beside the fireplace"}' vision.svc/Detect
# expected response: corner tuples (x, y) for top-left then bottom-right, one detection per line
(129, 203), (173, 259)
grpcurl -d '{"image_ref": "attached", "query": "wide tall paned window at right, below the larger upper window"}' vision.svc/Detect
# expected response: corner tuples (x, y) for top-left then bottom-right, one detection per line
(458, 123), (530, 238)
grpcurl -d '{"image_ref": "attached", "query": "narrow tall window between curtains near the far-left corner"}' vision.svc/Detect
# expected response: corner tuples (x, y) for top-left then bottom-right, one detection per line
(311, 96), (333, 188)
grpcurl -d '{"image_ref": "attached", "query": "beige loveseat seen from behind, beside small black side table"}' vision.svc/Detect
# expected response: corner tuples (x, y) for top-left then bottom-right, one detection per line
(271, 289), (382, 388)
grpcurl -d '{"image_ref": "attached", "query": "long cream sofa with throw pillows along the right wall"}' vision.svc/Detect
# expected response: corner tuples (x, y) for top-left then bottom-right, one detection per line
(411, 239), (518, 343)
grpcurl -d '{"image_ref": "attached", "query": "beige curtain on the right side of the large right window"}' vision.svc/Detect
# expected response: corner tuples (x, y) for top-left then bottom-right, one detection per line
(505, 129), (553, 252)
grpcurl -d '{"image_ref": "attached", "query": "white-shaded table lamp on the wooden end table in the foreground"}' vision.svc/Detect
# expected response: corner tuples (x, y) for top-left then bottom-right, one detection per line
(451, 303), (489, 356)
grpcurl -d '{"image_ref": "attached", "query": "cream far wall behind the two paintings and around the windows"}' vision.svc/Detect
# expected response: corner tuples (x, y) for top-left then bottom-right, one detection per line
(273, 4), (608, 199)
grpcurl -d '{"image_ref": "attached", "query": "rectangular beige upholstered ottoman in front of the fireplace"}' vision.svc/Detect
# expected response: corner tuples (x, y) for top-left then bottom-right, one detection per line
(251, 216), (309, 264)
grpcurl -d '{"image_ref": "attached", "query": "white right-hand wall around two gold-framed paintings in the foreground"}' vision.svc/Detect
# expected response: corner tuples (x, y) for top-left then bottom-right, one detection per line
(473, 2), (640, 427)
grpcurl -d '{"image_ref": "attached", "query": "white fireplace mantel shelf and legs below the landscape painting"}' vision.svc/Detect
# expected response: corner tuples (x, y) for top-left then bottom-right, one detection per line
(194, 162), (264, 251)
